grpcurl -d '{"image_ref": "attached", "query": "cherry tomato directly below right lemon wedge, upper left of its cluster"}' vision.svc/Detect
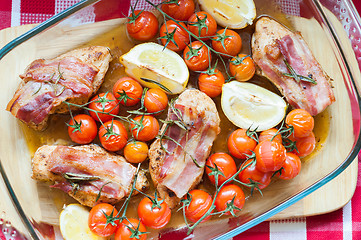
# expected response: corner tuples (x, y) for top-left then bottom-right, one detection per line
(228, 128), (257, 159)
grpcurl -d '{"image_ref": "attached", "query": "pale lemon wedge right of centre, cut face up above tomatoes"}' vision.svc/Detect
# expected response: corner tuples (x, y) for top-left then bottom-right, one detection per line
(221, 81), (287, 131)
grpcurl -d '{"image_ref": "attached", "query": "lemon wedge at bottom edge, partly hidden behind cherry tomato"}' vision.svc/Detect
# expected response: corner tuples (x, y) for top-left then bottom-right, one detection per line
(59, 204), (105, 240)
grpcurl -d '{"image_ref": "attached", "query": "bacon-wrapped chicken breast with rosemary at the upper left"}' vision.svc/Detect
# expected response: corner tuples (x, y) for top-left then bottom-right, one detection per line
(6, 46), (112, 130)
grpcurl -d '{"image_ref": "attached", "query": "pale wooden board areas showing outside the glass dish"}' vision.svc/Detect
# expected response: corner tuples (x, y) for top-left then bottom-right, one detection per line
(0, 8), (361, 235)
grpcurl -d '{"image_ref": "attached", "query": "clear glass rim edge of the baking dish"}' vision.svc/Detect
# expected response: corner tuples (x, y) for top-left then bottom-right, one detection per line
(0, 0), (361, 240)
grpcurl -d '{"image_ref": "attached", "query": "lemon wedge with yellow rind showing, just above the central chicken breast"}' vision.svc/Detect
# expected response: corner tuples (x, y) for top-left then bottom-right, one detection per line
(120, 43), (189, 94)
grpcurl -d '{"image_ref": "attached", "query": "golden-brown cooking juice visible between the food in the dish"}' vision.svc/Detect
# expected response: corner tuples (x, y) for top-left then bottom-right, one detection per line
(22, 0), (330, 232)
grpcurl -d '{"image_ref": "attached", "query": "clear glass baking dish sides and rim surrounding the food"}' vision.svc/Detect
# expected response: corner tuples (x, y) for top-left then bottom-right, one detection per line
(0, 0), (361, 239)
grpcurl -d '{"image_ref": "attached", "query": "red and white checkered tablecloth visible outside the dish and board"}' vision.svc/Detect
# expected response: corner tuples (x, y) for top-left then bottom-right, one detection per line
(0, 0), (361, 240)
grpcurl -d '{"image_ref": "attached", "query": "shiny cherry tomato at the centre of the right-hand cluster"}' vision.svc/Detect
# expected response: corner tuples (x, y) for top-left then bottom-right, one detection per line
(254, 141), (286, 172)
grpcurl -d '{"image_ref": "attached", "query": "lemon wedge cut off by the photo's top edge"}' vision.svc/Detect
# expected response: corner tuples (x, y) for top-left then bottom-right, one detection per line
(199, 0), (256, 29)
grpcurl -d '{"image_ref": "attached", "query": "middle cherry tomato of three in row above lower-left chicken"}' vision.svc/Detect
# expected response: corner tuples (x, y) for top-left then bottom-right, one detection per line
(99, 120), (128, 152)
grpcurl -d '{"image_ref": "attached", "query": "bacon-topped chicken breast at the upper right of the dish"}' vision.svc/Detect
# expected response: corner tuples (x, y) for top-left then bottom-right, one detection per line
(252, 17), (335, 115)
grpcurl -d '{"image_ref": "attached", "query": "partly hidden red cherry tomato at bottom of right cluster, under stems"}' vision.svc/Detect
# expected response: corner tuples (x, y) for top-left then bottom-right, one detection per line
(238, 160), (272, 190)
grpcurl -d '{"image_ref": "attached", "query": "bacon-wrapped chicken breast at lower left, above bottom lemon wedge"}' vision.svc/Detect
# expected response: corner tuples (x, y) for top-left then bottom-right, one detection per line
(32, 145), (147, 206)
